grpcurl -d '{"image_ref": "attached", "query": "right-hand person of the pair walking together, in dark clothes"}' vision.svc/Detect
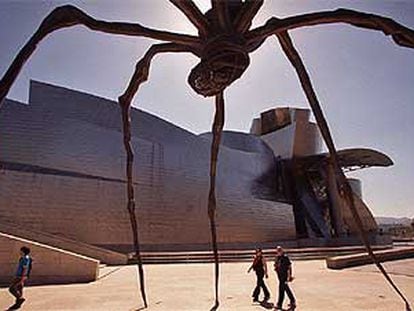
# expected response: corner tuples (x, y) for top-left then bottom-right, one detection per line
(275, 246), (296, 310)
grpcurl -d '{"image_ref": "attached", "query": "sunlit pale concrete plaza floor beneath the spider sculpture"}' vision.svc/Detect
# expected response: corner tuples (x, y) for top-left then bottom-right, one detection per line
(0, 259), (414, 311)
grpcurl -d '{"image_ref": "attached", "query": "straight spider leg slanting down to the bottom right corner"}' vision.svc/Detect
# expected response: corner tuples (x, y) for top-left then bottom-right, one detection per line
(277, 31), (411, 311)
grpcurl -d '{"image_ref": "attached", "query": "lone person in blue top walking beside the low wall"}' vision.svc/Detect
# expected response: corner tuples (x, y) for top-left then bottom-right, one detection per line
(9, 246), (33, 310)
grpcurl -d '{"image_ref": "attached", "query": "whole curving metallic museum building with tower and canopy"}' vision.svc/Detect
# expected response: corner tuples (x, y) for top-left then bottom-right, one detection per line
(0, 81), (393, 253)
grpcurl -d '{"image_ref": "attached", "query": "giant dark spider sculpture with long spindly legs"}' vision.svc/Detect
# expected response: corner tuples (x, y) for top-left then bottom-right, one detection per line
(0, 0), (414, 310)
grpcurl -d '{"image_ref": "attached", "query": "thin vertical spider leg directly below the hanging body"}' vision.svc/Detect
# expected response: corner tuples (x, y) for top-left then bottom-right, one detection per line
(208, 92), (224, 311)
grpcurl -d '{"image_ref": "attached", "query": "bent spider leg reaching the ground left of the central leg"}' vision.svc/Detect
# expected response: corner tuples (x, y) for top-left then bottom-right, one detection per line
(118, 43), (190, 308)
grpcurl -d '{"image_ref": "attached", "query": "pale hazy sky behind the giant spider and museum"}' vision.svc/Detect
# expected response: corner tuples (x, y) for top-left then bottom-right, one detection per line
(0, 0), (414, 217)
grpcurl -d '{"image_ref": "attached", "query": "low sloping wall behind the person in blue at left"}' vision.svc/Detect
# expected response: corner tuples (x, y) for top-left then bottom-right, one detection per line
(0, 232), (99, 285)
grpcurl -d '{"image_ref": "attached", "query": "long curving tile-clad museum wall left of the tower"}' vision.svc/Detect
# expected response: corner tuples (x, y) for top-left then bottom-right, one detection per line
(0, 83), (295, 254)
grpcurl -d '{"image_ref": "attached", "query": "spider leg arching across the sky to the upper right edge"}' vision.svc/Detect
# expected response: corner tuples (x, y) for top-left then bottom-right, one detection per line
(246, 9), (414, 48)
